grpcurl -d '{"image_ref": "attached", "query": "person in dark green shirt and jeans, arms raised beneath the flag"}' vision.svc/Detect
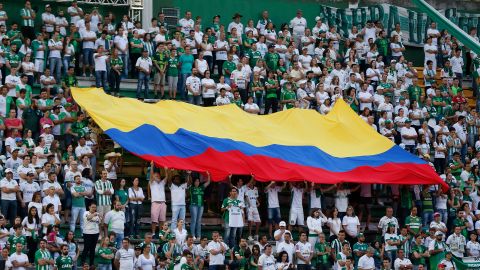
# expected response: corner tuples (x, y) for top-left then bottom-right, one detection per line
(188, 172), (210, 239)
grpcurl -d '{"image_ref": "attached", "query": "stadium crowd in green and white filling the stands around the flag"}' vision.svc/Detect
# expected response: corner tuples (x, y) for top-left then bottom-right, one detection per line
(0, 1), (480, 270)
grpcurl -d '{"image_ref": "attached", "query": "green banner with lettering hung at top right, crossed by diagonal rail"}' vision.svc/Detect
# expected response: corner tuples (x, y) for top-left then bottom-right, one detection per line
(320, 4), (480, 45)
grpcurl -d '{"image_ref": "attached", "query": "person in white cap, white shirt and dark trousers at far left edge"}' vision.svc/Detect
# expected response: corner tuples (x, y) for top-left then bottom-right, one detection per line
(0, 168), (20, 225)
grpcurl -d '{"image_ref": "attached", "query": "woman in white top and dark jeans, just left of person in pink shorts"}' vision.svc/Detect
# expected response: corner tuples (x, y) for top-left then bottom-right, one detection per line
(126, 178), (145, 237)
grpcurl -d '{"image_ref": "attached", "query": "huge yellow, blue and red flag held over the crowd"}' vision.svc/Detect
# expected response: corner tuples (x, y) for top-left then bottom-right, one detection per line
(73, 88), (446, 187)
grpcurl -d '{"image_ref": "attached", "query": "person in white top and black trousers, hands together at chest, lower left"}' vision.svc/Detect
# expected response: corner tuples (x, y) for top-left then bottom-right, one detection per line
(81, 202), (102, 266)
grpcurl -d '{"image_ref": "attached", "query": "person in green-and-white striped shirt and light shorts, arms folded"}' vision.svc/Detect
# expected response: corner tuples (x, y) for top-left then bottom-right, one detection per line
(95, 170), (114, 237)
